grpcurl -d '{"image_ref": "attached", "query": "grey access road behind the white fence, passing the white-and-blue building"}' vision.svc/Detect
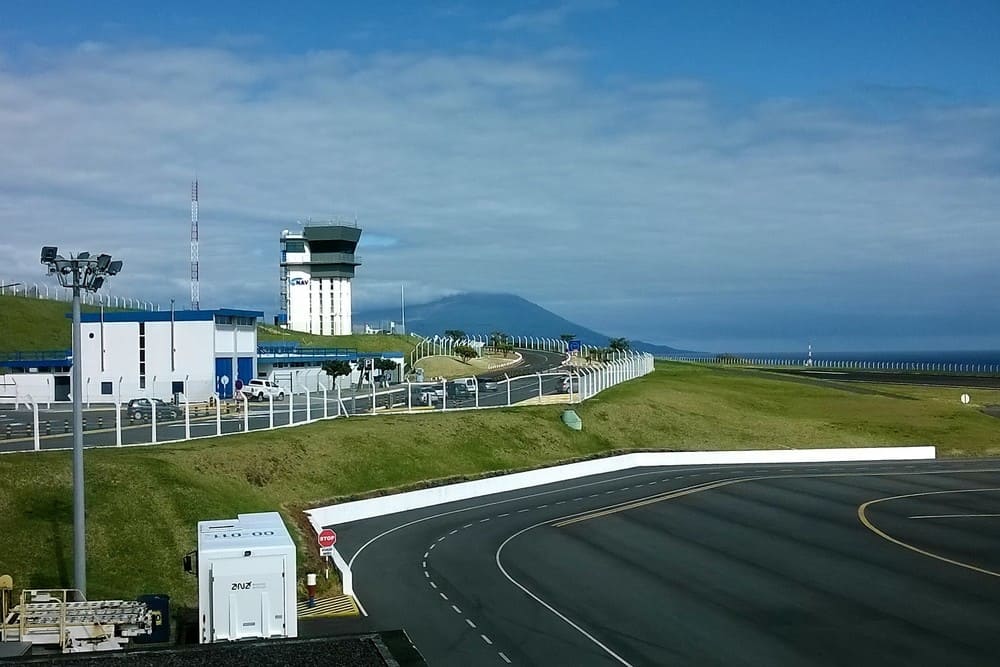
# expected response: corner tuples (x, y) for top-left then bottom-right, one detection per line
(0, 350), (563, 452)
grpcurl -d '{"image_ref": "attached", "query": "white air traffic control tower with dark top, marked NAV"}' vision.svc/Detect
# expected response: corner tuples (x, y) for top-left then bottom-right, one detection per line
(278, 224), (361, 336)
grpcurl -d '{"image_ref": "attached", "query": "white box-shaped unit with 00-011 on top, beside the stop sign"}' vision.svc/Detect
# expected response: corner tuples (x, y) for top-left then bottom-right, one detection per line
(197, 512), (298, 644)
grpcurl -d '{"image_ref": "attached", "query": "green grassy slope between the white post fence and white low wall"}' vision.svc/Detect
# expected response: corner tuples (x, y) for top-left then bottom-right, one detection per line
(0, 364), (1000, 604)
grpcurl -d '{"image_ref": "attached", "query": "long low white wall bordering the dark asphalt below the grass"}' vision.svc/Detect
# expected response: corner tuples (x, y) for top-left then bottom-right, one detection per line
(306, 447), (935, 533)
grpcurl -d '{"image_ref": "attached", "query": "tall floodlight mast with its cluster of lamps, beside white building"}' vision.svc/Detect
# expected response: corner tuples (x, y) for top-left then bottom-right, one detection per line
(41, 246), (122, 597)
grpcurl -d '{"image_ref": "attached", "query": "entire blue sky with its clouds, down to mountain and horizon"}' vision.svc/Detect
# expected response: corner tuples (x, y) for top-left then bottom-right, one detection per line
(0, 0), (1000, 353)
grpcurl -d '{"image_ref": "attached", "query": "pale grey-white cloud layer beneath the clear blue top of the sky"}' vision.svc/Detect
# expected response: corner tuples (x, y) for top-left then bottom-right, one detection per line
(0, 44), (1000, 349)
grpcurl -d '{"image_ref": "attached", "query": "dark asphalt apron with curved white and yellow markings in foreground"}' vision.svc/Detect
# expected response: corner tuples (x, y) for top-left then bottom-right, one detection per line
(334, 460), (1000, 667)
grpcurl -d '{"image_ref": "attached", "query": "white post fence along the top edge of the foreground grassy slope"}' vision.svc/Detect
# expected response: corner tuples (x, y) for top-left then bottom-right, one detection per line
(0, 352), (653, 453)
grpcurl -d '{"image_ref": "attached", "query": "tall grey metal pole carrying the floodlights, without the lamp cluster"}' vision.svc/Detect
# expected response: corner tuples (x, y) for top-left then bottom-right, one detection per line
(72, 274), (87, 599)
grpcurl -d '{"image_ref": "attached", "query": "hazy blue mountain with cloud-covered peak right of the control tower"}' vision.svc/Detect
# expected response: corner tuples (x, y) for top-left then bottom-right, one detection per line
(352, 292), (682, 354)
